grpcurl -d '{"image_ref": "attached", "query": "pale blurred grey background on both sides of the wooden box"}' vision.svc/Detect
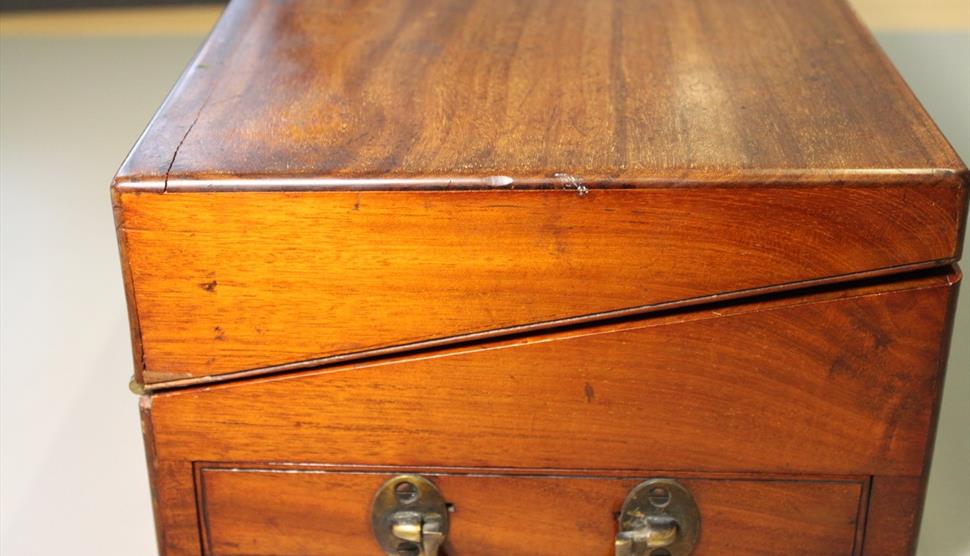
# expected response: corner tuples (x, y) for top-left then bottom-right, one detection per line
(0, 0), (970, 556)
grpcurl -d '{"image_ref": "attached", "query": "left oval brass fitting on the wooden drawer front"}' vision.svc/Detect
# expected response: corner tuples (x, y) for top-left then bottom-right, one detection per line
(371, 475), (448, 556)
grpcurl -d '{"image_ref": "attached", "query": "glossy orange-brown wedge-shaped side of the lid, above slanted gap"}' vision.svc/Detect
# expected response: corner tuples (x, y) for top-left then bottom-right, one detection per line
(113, 185), (965, 383)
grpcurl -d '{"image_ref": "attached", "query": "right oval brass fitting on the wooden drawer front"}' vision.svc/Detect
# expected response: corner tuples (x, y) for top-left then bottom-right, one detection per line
(615, 479), (701, 556)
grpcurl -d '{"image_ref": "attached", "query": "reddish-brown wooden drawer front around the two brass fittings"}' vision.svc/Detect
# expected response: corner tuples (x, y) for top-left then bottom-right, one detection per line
(198, 467), (866, 556)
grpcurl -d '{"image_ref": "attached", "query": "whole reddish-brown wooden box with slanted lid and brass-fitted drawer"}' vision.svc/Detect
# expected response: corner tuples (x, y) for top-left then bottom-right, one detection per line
(112, 0), (968, 556)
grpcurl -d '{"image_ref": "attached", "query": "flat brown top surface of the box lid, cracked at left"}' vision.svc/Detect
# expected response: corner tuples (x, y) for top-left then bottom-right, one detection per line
(113, 0), (964, 185)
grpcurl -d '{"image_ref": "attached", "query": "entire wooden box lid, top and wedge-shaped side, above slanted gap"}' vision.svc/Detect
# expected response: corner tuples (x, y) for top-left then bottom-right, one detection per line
(114, 0), (968, 384)
